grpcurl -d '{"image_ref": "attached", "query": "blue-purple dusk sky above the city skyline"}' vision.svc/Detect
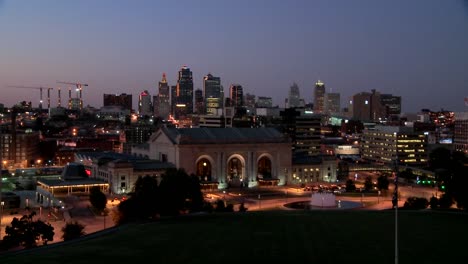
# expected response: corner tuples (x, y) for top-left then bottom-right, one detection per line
(0, 0), (468, 112)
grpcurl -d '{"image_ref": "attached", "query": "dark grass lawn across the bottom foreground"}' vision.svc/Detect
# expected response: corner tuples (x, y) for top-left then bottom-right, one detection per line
(0, 211), (468, 264)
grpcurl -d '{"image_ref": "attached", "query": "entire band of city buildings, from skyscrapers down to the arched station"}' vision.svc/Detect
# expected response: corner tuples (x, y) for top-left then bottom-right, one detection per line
(0, 66), (468, 198)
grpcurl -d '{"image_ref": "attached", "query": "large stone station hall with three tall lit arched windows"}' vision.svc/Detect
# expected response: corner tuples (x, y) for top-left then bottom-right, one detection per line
(132, 126), (292, 189)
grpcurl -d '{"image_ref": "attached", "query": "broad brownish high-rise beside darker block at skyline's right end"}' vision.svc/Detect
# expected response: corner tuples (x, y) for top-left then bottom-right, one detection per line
(350, 89), (385, 122)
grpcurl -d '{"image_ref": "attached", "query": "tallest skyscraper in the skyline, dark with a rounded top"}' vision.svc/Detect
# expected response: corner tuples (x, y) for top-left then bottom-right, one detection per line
(175, 65), (193, 118)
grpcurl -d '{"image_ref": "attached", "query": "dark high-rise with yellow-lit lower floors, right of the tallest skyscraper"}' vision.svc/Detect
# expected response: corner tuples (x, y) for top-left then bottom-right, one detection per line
(203, 73), (224, 115)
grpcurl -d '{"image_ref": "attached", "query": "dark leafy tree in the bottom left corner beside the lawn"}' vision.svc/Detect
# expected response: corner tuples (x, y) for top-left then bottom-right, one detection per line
(3, 212), (55, 248)
